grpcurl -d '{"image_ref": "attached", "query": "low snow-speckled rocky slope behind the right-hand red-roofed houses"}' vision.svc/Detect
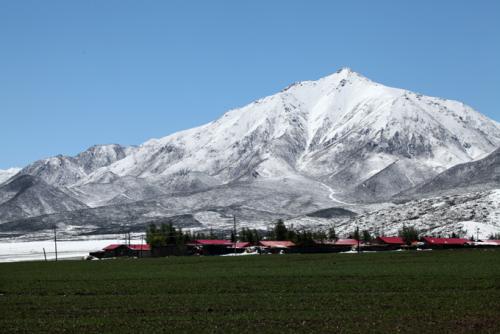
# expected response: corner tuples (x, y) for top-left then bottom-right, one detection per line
(286, 189), (500, 238)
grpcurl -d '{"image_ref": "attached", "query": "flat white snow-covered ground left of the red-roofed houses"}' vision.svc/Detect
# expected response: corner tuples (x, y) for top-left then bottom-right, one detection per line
(0, 239), (123, 262)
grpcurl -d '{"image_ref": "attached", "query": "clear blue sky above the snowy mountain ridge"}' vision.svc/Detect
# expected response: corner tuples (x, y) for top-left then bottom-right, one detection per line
(0, 0), (500, 168)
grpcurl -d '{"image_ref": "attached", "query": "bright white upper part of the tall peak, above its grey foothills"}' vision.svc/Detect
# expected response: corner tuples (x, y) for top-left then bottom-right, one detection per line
(68, 69), (500, 202)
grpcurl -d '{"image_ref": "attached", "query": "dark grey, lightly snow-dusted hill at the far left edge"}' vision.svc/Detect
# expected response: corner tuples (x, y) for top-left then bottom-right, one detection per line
(0, 175), (87, 223)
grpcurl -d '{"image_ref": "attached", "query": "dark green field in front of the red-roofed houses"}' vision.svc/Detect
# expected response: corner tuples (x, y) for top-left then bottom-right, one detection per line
(0, 250), (500, 333)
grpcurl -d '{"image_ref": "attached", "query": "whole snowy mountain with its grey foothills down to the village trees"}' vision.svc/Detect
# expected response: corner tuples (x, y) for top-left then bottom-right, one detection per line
(0, 69), (500, 239)
